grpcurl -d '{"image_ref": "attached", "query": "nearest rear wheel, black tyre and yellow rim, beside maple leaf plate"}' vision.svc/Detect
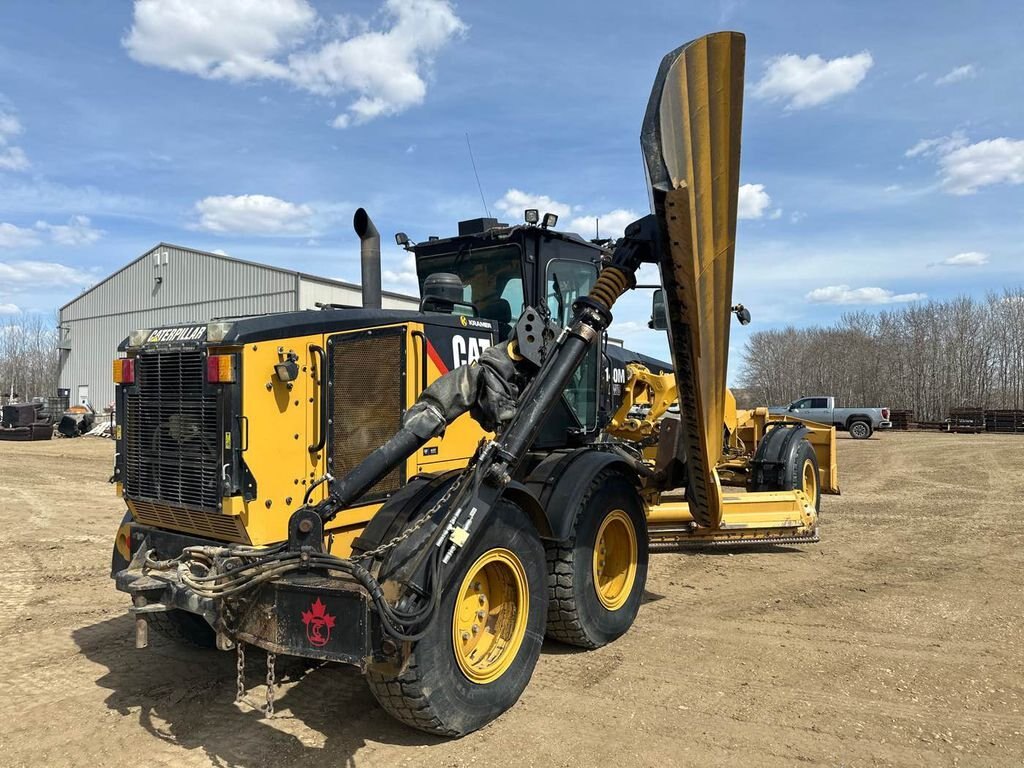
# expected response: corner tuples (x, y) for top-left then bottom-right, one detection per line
(367, 500), (548, 736)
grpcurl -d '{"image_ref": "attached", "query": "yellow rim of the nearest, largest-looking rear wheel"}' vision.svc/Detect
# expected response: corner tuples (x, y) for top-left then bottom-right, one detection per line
(452, 549), (529, 685)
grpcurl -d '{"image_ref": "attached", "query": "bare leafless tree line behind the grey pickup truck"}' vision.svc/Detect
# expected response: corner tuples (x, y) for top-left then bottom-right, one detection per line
(739, 288), (1024, 421)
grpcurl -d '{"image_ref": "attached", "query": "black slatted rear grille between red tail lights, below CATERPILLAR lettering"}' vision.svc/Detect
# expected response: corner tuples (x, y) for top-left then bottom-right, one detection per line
(123, 351), (221, 511)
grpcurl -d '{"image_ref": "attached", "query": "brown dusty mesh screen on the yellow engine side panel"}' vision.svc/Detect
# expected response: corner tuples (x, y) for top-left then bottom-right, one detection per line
(329, 329), (406, 502)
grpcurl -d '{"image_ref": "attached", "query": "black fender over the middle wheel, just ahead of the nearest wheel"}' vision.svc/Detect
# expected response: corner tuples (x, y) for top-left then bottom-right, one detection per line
(513, 447), (640, 542)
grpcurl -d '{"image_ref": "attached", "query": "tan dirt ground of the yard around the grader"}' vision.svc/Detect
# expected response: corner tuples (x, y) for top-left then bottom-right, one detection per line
(0, 433), (1024, 768)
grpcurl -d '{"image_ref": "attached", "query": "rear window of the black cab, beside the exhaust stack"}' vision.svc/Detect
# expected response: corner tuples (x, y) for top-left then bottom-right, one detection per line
(417, 245), (523, 331)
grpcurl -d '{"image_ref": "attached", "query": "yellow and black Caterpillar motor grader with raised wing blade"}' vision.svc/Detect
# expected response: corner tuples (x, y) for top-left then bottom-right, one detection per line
(112, 33), (835, 736)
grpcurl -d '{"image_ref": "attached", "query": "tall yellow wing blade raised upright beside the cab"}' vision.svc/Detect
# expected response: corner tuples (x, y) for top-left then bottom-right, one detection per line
(641, 32), (745, 527)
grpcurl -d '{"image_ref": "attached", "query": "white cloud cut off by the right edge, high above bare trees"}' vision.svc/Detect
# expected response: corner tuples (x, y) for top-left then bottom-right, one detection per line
(905, 131), (1024, 195)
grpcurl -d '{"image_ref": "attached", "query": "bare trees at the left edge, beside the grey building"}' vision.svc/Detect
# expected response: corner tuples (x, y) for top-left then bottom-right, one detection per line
(0, 313), (58, 401)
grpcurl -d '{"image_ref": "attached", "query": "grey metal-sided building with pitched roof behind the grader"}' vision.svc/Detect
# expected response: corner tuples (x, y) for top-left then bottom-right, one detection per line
(58, 243), (419, 411)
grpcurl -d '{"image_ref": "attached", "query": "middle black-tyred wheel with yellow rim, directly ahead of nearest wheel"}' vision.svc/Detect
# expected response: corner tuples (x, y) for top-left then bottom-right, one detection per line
(548, 470), (647, 648)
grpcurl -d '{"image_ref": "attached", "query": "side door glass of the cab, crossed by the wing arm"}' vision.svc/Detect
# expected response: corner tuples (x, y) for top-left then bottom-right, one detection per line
(545, 259), (601, 429)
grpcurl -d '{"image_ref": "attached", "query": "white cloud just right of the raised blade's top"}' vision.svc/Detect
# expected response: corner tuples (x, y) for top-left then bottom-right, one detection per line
(754, 50), (874, 110)
